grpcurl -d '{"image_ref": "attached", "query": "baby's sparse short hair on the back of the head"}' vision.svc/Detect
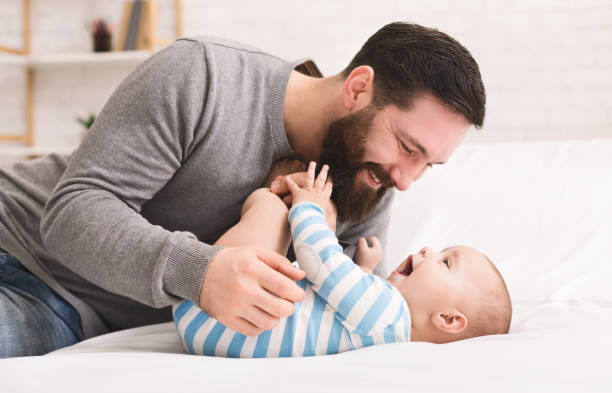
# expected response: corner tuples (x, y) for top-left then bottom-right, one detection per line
(464, 256), (512, 338)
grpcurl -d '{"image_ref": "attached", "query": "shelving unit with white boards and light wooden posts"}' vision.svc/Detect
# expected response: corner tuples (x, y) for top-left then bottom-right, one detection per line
(0, 0), (183, 157)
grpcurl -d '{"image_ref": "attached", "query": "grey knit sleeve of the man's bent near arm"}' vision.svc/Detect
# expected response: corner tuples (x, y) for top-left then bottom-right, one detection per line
(40, 40), (219, 307)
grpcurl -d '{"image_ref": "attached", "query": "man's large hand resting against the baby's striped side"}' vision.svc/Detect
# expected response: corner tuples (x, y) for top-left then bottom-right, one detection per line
(200, 247), (305, 336)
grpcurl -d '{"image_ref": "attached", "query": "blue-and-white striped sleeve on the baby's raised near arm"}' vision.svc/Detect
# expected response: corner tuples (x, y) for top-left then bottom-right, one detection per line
(289, 202), (410, 340)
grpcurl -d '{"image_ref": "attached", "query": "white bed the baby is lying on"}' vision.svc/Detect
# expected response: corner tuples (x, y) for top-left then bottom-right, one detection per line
(0, 138), (612, 392)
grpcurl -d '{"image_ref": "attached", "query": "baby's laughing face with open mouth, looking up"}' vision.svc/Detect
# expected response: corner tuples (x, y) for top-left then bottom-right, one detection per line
(387, 246), (495, 315)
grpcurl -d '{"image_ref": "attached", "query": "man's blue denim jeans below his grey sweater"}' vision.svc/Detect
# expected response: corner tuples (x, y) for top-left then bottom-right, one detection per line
(0, 249), (83, 359)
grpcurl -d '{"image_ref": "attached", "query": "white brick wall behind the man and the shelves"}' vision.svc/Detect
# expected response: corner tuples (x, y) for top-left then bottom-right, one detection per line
(0, 0), (612, 160)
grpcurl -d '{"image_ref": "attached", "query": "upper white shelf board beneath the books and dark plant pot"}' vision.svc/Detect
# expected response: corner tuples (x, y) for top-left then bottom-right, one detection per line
(0, 50), (151, 68)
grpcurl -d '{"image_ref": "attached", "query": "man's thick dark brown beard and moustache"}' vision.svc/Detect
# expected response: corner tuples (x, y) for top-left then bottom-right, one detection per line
(319, 105), (393, 223)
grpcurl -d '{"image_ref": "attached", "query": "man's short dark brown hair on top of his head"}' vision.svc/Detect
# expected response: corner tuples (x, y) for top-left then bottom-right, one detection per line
(342, 22), (486, 128)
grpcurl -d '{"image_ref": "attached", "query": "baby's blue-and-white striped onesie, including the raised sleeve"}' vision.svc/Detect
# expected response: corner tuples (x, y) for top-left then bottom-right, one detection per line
(173, 202), (410, 358)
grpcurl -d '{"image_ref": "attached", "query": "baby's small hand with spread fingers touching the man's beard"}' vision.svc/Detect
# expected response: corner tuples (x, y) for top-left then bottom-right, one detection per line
(286, 161), (333, 209)
